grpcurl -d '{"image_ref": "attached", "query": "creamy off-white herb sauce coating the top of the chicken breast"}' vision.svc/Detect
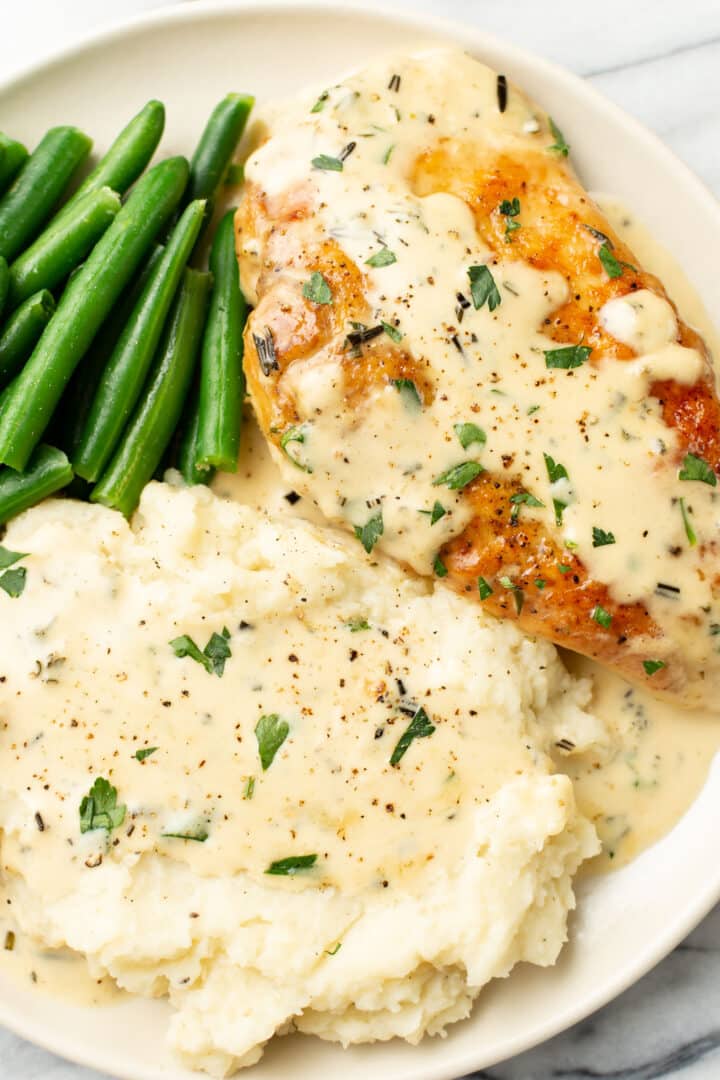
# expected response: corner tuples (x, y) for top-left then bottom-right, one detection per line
(241, 50), (720, 697)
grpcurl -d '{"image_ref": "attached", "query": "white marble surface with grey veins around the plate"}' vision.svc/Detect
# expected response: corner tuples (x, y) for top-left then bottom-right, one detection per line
(0, 0), (720, 1080)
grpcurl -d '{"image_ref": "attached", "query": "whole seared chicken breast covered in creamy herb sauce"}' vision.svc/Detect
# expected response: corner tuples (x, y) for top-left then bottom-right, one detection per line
(236, 49), (720, 703)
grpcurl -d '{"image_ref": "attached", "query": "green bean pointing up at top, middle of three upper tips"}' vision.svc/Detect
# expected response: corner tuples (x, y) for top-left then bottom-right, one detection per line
(62, 100), (165, 214)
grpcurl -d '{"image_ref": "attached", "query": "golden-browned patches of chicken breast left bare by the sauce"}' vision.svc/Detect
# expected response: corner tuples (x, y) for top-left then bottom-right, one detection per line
(236, 46), (720, 701)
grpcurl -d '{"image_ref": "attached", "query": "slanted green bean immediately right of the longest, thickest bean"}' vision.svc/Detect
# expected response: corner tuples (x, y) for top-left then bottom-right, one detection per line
(72, 199), (205, 481)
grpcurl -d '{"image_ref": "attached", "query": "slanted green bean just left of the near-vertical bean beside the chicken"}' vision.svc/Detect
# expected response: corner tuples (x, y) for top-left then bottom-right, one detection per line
(91, 270), (212, 517)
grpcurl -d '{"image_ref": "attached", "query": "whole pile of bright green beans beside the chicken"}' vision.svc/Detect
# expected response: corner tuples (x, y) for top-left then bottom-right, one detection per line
(0, 94), (254, 525)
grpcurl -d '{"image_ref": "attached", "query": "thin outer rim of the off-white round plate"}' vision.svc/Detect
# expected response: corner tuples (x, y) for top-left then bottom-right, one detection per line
(0, 8), (720, 1080)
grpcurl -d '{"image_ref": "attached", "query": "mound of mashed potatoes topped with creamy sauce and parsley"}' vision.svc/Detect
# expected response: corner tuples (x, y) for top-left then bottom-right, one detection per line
(0, 484), (601, 1076)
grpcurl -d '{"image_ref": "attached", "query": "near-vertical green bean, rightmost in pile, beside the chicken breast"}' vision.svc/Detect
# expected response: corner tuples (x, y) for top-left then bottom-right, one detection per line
(194, 210), (247, 472)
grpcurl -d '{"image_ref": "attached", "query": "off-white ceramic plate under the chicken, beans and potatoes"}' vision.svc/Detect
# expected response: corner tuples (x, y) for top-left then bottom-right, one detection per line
(0, 2), (720, 1080)
